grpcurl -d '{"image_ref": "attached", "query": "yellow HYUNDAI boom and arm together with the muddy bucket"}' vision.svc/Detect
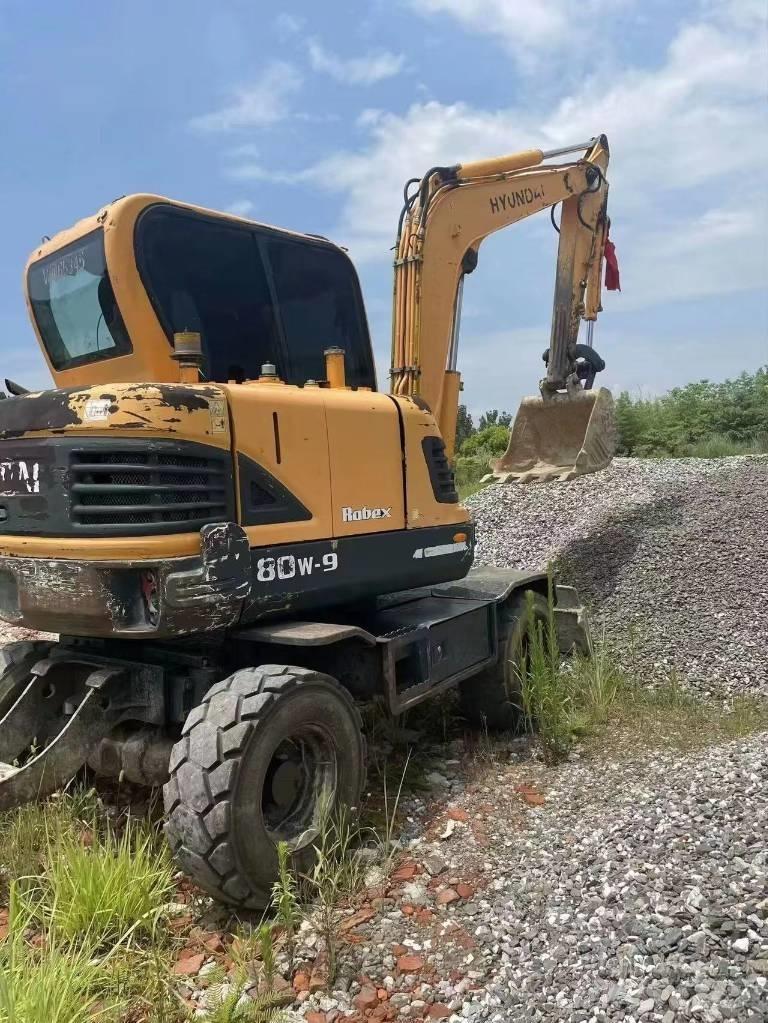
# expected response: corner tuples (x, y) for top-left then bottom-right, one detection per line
(391, 135), (615, 482)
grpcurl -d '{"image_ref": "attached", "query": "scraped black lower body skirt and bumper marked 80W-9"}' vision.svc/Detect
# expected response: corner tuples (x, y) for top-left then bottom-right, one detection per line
(0, 523), (475, 638)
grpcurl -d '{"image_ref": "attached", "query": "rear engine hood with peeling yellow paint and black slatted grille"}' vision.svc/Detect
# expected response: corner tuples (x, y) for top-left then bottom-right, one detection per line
(0, 384), (235, 546)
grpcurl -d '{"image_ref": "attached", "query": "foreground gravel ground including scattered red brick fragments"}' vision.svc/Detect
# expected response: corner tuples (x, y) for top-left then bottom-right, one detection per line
(290, 733), (768, 1023)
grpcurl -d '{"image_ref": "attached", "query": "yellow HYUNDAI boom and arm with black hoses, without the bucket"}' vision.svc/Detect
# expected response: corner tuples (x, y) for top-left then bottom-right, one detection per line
(391, 135), (609, 475)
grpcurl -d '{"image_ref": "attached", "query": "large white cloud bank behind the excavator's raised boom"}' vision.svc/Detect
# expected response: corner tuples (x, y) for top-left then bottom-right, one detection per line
(230, 0), (768, 308)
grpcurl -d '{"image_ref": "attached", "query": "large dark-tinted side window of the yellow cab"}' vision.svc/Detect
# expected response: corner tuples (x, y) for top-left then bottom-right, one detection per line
(136, 204), (375, 388)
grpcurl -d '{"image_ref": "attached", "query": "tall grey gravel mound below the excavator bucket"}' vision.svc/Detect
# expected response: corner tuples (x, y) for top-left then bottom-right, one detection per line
(468, 456), (768, 694)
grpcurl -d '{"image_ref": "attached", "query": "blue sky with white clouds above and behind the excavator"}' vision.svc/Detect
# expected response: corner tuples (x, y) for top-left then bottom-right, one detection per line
(0, 0), (768, 410)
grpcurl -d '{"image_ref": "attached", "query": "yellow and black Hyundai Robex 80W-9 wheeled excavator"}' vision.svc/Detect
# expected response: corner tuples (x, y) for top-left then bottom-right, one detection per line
(0, 136), (612, 906)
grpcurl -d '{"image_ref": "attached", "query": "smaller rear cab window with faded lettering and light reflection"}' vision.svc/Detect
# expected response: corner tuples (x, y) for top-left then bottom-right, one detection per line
(27, 228), (131, 369)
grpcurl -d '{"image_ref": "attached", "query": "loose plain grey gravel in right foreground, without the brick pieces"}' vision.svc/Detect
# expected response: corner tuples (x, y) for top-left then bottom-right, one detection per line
(478, 735), (768, 1023)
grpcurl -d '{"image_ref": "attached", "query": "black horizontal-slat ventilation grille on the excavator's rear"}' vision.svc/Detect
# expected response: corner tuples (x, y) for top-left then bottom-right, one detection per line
(70, 444), (231, 534)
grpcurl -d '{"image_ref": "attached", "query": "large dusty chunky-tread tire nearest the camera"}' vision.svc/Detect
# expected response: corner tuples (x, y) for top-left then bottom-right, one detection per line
(164, 664), (365, 909)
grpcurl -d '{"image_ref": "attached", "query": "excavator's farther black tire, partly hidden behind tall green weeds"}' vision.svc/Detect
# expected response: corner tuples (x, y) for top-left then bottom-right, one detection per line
(459, 593), (548, 731)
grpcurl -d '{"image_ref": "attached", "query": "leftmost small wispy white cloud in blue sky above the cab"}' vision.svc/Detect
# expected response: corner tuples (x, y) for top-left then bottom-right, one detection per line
(190, 60), (302, 132)
